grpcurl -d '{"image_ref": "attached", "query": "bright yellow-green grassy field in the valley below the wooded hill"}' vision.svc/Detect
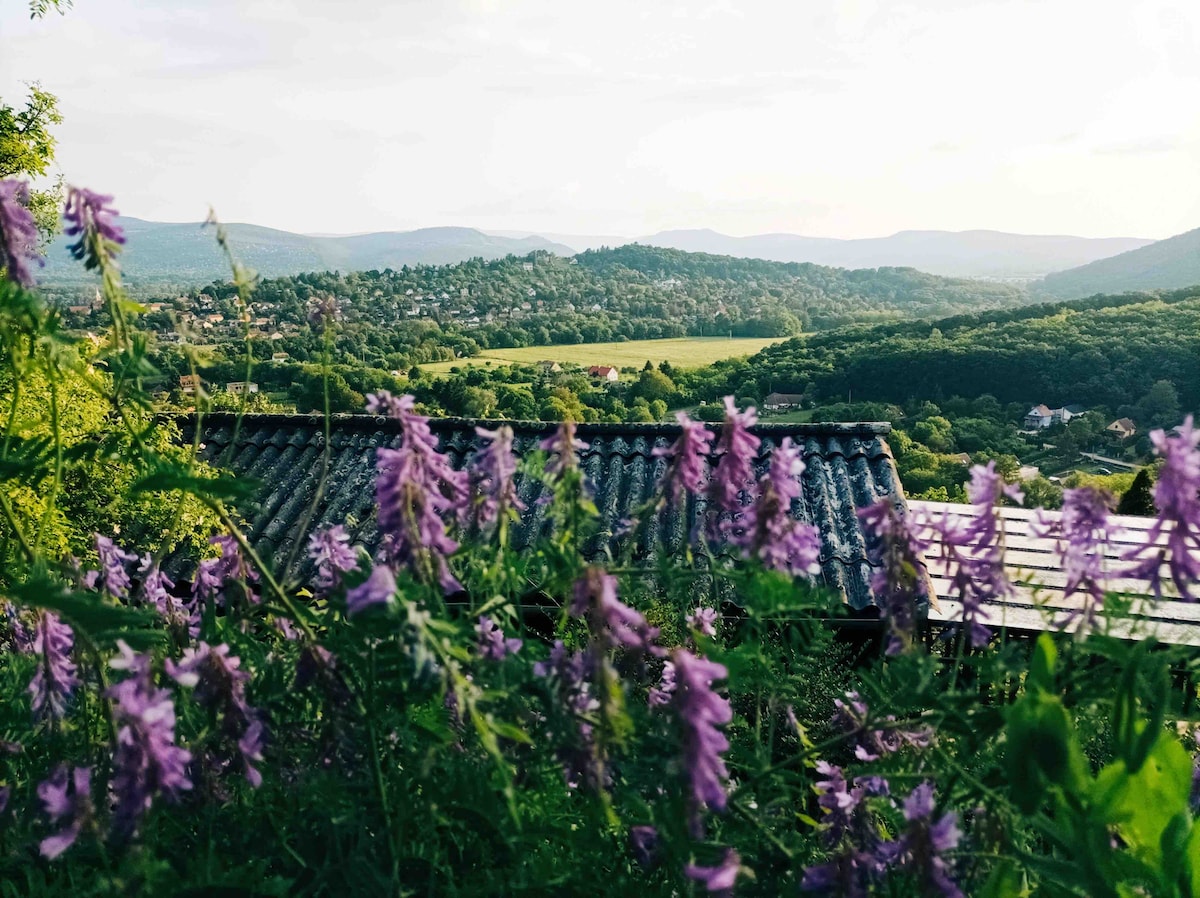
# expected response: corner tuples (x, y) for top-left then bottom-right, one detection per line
(421, 337), (780, 375)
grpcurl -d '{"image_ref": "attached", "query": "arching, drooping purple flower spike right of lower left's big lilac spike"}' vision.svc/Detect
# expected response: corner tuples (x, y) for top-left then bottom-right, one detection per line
(164, 642), (263, 789)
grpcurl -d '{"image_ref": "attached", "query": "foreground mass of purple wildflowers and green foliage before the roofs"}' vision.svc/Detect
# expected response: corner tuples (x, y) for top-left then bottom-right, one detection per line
(7, 182), (1200, 898)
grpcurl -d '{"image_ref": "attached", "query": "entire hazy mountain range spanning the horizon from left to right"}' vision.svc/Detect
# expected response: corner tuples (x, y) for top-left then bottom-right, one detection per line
(40, 217), (1200, 292)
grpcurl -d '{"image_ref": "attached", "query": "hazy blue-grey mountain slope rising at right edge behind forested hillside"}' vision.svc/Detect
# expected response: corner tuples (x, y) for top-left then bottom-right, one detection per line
(1033, 228), (1200, 299)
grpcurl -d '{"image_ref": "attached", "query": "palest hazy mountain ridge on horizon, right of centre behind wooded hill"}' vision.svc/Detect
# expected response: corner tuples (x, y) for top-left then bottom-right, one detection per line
(638, 231), (1153, 280)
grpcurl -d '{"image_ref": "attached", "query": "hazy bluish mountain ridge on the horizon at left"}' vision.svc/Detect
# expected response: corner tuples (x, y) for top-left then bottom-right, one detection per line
(38, 217), (575, 285)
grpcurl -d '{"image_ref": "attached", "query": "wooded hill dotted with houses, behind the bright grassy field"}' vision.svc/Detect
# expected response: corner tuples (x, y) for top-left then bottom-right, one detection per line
(71, 245), (1028, 371)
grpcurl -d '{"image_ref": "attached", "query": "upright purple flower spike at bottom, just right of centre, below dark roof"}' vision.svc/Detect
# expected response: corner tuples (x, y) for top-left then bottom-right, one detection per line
(671, 648), (733, 837)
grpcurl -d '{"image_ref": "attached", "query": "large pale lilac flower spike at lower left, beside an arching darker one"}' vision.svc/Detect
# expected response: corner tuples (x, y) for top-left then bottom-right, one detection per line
(106, 640), (192, 838)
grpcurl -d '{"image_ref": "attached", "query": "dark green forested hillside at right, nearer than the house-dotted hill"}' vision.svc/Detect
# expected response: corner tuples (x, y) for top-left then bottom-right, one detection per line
(708, 288), (1200, 409)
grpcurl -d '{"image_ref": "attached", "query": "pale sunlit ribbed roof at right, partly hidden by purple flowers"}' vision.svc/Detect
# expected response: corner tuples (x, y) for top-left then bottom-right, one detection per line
(908, 499), (1200, 646)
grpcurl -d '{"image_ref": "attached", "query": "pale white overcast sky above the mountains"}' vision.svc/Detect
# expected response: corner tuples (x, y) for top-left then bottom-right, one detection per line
(0, 0), (1200, 238)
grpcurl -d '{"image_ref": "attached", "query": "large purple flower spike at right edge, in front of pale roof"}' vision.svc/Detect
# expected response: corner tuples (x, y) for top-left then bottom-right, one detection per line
(1124, 415), (1200, 601)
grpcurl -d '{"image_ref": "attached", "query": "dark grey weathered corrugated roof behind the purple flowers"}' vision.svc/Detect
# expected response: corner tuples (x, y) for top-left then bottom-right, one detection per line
(181, 413), (905, 610)
